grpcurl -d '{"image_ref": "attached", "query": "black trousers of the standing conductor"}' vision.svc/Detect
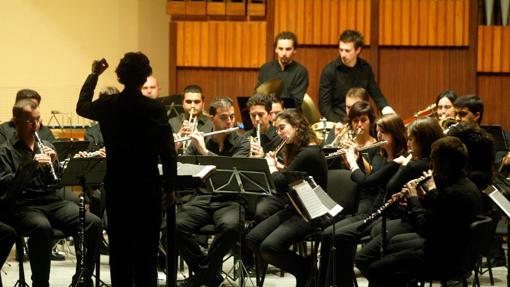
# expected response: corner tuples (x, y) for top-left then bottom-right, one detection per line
(106, 190), (162, 287)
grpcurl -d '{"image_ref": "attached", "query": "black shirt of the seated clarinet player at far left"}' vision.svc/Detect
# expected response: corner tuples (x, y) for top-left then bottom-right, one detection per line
(0, 137), (61, 205)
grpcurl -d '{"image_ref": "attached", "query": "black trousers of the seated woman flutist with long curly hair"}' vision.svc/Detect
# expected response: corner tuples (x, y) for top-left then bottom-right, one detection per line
(246, 209), (313, 286)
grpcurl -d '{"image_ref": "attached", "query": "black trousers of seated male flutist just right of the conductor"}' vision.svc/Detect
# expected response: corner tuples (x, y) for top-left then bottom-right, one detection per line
(176, 195), (244, 282)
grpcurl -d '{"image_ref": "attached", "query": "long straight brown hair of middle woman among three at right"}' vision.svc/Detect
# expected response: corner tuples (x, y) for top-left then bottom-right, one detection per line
(376, 114), (407, 158)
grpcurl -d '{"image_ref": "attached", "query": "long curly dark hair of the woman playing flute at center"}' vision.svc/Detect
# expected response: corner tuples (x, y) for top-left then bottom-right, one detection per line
(276, 109), (320, 165)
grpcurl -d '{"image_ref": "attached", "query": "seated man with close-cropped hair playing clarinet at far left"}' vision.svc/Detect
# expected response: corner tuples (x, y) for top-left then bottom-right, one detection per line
(0, 99), (102, 287)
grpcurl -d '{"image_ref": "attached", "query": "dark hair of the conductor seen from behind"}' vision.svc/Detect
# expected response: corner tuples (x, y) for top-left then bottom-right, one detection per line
(115, 52), (152, 89)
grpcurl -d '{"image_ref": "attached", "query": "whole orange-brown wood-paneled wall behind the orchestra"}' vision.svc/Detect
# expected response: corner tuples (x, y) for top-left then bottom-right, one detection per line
(169, 0), (510, 129)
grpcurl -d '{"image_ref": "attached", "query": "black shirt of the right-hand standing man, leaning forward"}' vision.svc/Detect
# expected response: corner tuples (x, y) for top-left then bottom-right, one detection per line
(319, 58), (388, 122)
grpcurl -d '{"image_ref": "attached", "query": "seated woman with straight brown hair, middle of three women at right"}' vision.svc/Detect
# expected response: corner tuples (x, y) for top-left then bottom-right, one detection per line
(319, 114), (407, 286)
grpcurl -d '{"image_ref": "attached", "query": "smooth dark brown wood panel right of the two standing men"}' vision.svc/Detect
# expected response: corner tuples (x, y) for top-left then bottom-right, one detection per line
(379, 47), (476, 121)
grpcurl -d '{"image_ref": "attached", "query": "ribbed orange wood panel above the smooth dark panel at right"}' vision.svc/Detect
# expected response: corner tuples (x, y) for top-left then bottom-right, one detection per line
(379, 0), (469, 46)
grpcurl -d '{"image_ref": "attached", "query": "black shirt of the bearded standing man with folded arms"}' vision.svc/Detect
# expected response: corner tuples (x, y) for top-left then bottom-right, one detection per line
(257, 60), (308, 110)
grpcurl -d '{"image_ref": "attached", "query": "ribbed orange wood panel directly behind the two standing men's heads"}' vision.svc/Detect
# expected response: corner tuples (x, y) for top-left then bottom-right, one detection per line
(274, 0), (371, 45)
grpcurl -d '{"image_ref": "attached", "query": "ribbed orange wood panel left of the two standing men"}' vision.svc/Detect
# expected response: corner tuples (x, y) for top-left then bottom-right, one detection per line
(176, 21), (266, 68)
